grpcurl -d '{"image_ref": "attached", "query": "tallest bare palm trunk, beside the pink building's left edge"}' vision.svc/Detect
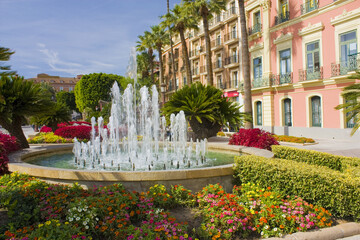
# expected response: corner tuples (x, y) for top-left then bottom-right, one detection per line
(238, 0), (253, 129)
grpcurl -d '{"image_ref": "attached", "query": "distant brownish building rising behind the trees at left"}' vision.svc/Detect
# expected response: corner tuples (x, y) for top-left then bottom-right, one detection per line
(26, 73), (82, 92)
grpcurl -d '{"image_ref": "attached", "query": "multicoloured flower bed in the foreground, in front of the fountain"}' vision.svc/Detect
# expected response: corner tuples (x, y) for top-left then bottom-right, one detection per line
(0, 173), (332, 239)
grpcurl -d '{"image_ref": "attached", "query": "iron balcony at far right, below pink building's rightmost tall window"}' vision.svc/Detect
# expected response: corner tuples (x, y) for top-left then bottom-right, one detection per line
(331, 53), (360, 77)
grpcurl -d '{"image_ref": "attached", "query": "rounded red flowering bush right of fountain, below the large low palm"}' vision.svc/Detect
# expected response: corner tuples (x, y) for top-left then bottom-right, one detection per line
(229, 128), (279, 151)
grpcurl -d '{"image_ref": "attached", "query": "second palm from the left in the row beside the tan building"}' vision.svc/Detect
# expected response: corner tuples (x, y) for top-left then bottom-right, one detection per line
(151, 25), (169, 94)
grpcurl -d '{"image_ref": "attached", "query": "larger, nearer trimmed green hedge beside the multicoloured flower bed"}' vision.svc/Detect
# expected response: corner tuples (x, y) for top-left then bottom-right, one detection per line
(234, 155), (360, 220)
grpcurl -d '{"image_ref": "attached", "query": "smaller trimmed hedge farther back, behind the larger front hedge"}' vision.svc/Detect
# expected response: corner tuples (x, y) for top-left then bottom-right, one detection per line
(272, 145), (344, 171)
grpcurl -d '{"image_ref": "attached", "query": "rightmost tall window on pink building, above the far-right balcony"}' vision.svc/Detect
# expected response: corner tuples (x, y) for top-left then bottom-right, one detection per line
(340, 31), (357, 71)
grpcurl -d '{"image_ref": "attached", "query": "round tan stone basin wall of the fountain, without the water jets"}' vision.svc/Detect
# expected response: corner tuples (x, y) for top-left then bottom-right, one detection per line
(9, 142), (272, 192)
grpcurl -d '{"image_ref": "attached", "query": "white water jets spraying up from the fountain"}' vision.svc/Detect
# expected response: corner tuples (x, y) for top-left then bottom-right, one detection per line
(73, 82), (206, 171)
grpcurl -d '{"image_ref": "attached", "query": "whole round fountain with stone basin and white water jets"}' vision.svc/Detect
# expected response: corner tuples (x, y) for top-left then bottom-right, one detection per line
(9, 49), (268, 192)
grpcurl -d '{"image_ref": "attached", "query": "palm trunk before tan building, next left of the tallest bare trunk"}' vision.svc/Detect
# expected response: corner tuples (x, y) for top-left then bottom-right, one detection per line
(201, 7), (214, 86)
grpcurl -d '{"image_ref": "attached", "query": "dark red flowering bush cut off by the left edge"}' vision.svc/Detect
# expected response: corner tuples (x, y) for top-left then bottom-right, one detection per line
(0, 133), (20, 175)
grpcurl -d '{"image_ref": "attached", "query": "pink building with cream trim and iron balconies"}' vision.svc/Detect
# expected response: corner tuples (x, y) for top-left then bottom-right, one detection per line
(246, 0), (360, 139)
